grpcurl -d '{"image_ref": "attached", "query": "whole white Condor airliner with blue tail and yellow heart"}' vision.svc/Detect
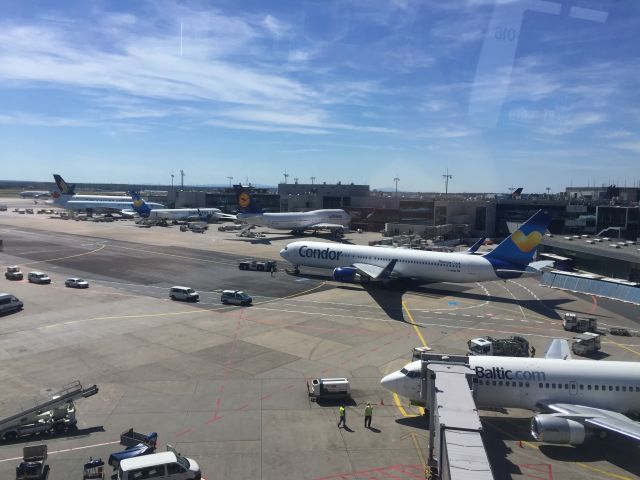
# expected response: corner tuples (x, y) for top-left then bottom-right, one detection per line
(280, 210), (553, 283)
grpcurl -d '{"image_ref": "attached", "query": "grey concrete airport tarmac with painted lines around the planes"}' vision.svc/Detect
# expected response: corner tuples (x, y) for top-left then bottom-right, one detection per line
(0, 200), (640, 480)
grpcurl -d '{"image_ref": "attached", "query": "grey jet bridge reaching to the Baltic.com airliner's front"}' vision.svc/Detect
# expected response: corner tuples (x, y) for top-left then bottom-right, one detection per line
(421, 352), (494, 480)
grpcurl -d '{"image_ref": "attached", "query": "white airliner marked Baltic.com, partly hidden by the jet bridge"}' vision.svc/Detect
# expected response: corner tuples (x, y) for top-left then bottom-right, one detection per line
(380, 339), (640, 445)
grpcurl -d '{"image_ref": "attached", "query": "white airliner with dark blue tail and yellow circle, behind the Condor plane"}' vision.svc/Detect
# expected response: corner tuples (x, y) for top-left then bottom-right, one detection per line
(233, 185), (351, 235)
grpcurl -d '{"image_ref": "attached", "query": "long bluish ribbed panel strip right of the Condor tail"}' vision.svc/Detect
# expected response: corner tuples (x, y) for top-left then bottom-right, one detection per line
(540, 272), (640, 305)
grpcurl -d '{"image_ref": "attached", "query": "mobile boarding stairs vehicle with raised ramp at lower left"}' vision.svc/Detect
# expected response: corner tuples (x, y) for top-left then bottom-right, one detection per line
(0, 382), (98, 441)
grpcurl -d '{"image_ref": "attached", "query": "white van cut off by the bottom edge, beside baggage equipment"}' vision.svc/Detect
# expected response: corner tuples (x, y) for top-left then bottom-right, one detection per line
(116, 447), (202, 480)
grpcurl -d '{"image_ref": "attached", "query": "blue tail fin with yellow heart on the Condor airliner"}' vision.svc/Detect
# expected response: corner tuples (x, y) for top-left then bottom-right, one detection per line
(484, 210), (551, 268)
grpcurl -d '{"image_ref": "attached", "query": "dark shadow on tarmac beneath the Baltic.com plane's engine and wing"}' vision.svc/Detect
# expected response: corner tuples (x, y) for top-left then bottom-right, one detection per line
(482, 417), (640, 479)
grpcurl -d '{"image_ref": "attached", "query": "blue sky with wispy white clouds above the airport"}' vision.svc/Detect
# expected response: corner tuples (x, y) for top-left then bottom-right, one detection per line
(0, 0), (640, 193)
